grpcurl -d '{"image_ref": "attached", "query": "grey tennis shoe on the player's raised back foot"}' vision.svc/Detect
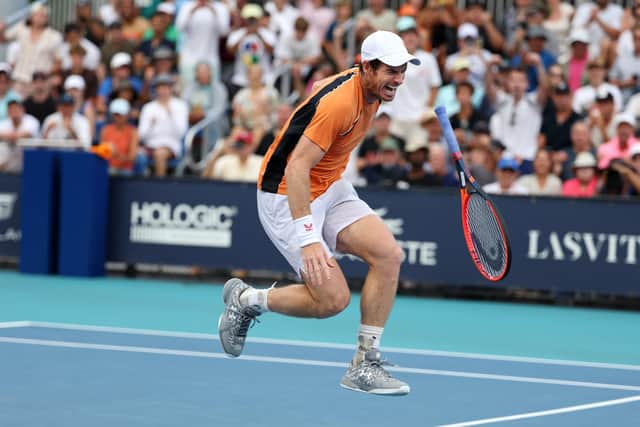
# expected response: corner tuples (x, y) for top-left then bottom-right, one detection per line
(218, 278), (260, 357)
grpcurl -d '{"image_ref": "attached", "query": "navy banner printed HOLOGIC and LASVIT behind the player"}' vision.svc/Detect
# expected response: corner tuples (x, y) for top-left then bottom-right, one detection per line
(108, 178), (640, 295)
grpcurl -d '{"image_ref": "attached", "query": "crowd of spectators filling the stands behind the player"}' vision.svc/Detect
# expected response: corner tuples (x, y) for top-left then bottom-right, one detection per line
(0, 0), (640, 197)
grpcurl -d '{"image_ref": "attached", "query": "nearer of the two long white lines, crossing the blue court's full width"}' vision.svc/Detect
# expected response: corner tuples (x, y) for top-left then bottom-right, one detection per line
(0, 337), (640, 392)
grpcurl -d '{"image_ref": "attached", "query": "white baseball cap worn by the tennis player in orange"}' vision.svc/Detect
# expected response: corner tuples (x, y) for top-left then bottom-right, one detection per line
(361, 31), (420, 67)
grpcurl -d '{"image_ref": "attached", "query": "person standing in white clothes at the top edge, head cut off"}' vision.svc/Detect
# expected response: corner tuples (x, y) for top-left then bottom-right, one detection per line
(176, 0), (230, 84)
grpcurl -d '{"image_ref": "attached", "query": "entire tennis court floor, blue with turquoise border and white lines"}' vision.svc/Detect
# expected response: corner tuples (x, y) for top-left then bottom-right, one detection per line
(0, 273), (640, 427)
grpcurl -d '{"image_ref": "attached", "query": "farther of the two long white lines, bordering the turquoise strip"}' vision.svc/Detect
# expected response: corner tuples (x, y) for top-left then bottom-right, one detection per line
(18, 321), (640, 371)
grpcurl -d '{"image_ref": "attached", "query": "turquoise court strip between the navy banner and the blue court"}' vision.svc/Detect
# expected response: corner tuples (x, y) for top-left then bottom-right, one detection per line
(0, 271), (640, 365)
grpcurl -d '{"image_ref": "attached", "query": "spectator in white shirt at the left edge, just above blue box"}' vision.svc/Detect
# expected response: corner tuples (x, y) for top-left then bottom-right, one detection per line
(0, 99), (40, 172)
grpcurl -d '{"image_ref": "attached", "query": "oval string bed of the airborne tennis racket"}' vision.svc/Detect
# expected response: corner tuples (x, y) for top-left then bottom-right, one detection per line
(467, 194), (508, 278)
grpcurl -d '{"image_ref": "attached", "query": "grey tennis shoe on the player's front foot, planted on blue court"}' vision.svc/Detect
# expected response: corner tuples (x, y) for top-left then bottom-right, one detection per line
(340, 350), (411, 395)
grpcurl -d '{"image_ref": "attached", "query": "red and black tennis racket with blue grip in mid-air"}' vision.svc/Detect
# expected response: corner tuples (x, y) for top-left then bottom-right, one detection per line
(435, 107), (511, 282)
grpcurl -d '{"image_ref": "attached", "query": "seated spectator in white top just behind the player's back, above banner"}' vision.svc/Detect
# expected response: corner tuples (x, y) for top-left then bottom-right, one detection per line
(203, 130), (262, 182)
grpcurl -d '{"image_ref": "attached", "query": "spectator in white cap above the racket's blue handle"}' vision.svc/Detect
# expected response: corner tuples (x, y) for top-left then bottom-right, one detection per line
(445, 22), (492, 86)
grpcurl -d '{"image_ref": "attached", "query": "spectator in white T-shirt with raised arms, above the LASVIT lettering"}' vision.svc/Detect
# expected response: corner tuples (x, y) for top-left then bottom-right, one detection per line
(487, 59), (547, 174)
